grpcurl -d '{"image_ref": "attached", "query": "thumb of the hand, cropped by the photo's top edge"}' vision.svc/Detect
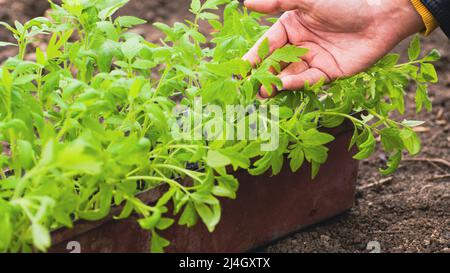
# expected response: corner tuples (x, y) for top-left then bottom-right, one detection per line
(244, 0), (306, 13)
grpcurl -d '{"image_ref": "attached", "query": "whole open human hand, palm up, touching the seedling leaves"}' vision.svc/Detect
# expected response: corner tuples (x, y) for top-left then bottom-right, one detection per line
(244, 0), (424, 98)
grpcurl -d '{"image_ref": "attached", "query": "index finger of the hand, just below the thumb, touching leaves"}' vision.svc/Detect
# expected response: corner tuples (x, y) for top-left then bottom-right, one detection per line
(243, 21), (288, 66)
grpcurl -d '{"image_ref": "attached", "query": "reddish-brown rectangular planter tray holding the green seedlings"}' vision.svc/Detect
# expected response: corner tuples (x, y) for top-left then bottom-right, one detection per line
(50, 126), (358, 253)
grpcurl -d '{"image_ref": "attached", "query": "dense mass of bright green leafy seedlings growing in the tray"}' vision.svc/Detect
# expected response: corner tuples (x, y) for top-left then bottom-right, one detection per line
(0, 0), (439, 252)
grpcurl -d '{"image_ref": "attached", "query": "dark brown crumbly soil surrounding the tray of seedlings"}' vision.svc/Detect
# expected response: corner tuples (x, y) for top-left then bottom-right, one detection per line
(0, 0), (450, 253)
